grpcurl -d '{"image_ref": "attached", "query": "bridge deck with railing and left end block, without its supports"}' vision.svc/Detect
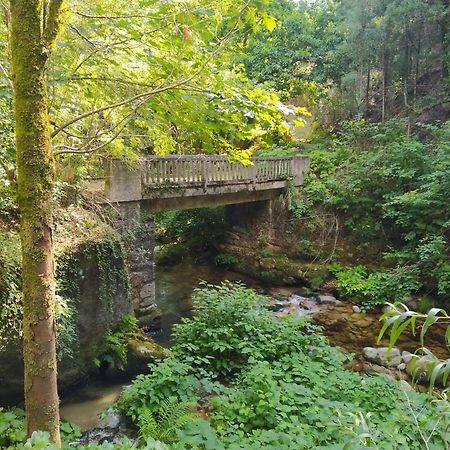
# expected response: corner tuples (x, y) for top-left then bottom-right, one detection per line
(105, 155), (309, 212)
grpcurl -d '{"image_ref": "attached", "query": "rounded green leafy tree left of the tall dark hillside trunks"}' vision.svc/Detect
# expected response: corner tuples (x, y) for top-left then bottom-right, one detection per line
(240, 0), (341, 102)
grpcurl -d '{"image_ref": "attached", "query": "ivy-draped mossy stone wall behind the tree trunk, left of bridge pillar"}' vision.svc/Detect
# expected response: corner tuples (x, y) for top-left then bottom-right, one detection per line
(0, 210), (131, 402)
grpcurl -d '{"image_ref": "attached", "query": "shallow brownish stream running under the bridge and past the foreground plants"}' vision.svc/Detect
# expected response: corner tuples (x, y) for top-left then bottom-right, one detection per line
(61, 258), (447, 431)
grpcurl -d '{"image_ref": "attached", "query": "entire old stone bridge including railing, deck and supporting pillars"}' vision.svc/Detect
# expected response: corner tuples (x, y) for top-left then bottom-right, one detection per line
(100, 155), (309, 318)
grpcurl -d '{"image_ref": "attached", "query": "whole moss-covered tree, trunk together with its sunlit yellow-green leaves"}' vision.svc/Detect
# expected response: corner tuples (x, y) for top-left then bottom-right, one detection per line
(0, 0), (283, 445)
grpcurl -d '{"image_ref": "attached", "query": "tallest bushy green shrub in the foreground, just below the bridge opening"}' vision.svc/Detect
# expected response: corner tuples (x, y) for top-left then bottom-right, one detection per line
(172, 283), (320, 377)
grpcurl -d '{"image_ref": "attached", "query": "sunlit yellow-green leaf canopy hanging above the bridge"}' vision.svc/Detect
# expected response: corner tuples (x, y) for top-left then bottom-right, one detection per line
(0, 0), (302, 174)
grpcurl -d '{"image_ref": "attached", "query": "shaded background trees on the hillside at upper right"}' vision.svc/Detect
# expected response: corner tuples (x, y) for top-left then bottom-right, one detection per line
(242, 0), (450, 121)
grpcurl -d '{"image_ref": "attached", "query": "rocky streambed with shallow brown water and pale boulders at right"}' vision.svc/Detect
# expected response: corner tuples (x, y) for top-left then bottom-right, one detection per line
(269, 288), (448, 390)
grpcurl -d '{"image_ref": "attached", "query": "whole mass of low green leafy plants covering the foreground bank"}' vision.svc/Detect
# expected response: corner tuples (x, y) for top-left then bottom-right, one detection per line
(114, 284), (448, 449)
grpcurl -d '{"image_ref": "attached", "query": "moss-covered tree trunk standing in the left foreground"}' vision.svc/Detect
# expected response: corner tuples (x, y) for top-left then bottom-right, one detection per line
(10, 0), (62, 445)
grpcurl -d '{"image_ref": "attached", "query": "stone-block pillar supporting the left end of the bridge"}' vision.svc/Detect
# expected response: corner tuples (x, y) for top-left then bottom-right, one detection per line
(117, 202), (156, 316)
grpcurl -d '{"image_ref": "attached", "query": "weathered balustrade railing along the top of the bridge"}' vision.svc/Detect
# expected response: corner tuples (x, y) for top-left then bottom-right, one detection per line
(141, 155), (308, 188)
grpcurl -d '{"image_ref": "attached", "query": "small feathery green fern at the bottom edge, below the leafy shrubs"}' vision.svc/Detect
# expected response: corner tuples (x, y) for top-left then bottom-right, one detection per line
(138, 397), (194, 443)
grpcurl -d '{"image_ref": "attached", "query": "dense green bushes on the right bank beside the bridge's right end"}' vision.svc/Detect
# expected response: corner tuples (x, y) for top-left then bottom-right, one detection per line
(290, 121), (450, 306)
